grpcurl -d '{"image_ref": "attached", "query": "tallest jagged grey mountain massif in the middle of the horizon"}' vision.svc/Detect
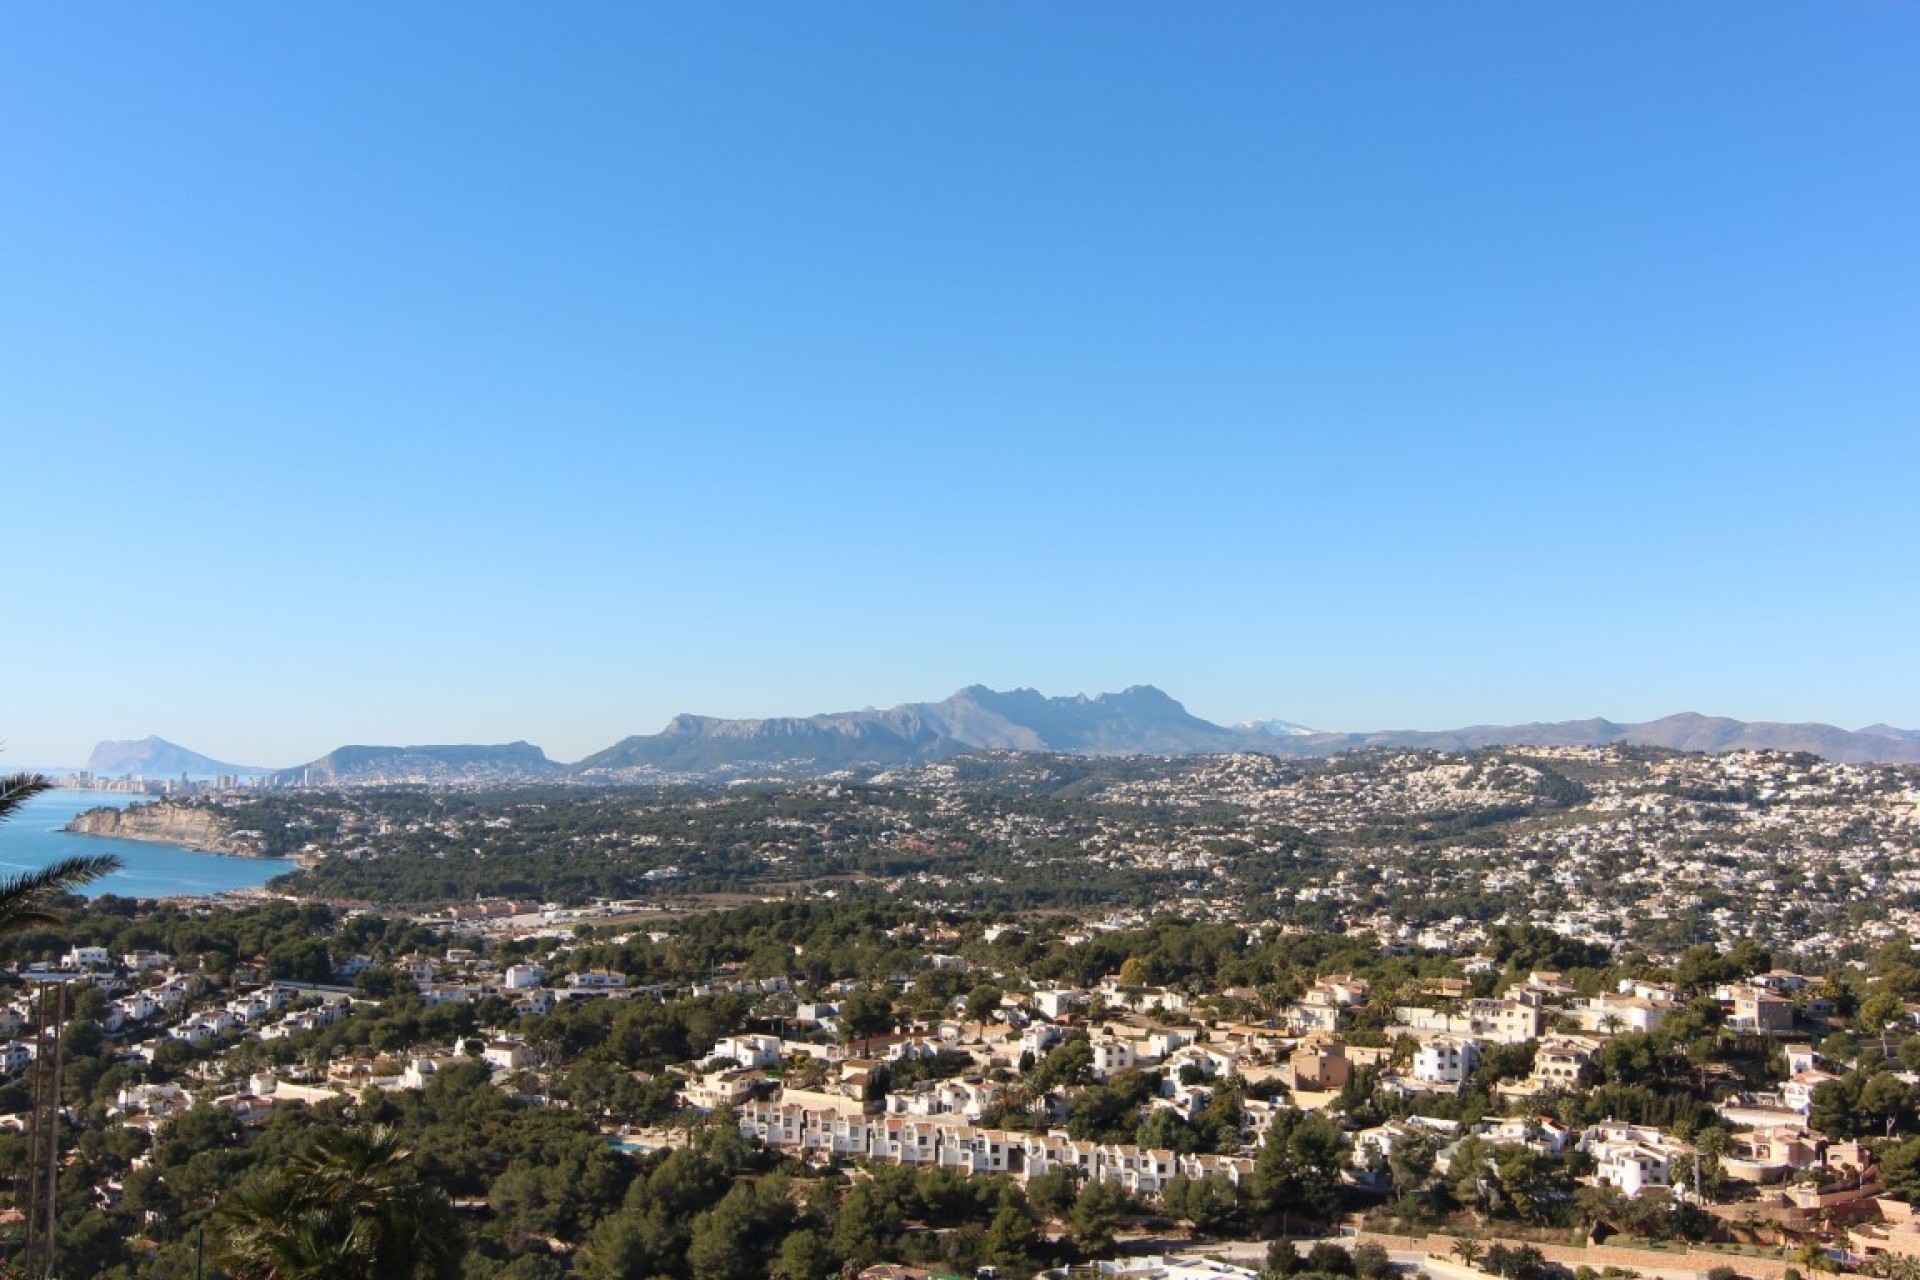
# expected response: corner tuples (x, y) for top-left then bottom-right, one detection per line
(576, 685), (1258, 773)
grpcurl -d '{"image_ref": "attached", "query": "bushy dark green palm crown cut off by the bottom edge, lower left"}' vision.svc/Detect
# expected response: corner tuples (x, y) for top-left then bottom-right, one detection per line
(215, 1125), (459, 1280)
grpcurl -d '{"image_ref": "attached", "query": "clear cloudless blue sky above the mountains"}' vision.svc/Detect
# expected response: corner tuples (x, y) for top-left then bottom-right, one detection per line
(0, 0), (1920, 766)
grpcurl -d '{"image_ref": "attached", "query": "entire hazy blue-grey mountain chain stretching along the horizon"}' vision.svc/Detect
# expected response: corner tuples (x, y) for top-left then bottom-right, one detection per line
(88, 685), (1920, 785)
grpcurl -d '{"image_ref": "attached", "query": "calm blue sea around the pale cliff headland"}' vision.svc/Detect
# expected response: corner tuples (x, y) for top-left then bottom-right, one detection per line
(0, 791), (300, 898)
